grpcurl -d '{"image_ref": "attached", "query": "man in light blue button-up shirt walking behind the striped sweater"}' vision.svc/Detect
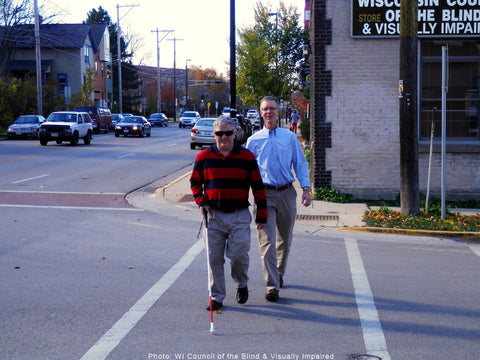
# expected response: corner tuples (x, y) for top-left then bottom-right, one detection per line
(246, 96), (312, 301)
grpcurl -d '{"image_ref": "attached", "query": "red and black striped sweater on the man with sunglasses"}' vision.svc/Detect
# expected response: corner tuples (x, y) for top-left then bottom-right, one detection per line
(190, 145), (268, 223)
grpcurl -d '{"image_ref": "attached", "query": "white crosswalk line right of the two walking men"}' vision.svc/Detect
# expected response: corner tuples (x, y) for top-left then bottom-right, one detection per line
(345, 239), (391, 360)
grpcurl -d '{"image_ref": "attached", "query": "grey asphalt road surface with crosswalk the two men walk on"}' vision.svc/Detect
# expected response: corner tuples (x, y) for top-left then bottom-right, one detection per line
(0, 126), (480, 360)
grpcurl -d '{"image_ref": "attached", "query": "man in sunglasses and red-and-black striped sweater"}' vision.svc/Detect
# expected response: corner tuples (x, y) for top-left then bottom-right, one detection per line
(190, 116), (268, 311)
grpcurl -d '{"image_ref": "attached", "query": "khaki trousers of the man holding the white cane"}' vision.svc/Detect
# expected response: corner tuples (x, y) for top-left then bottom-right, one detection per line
(207, 208), (252, 302)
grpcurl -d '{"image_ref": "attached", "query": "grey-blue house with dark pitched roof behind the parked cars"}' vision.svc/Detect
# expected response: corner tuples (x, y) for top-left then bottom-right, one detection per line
(7, 24), (113, 107)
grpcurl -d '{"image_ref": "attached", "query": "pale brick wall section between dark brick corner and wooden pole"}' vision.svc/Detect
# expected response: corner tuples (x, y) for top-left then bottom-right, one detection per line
(326, 0), (400, 197)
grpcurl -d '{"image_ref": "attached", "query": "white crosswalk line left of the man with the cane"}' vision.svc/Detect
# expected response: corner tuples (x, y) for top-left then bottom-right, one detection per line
(80, 239), (203, 360)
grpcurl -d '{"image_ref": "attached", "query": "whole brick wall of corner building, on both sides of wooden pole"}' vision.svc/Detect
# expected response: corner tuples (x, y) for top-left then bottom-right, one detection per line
(311, 0), (480, 199)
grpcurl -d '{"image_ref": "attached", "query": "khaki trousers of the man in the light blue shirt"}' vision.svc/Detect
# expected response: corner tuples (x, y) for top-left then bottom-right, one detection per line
(257, 186), (297, 290)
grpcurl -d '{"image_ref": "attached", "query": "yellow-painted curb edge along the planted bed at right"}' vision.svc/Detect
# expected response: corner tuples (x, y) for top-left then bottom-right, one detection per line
(339, 227), (480, 243)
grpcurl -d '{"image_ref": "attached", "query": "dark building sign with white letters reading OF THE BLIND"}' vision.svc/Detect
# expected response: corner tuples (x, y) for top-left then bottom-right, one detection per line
(352, 0), (480, 38)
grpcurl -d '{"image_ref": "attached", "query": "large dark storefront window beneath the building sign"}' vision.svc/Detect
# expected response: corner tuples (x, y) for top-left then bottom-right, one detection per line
(419, 39), (480, 141)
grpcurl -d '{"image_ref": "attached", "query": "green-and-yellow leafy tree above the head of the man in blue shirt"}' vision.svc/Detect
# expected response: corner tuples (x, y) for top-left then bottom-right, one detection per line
(237, 2), (306, 105)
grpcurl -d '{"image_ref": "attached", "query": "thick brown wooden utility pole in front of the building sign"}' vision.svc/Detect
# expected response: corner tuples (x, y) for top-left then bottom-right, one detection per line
(399, 0), (420, 215)
